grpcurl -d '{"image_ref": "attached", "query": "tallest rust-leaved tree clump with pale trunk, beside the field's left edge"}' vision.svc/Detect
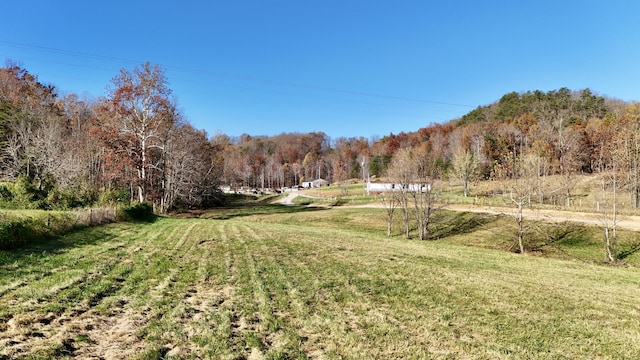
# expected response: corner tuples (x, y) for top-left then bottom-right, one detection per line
(91, 63), (224, 211)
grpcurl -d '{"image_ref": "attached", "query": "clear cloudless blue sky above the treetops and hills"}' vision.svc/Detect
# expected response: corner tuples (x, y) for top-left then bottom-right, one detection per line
(0, 0), (640, 139)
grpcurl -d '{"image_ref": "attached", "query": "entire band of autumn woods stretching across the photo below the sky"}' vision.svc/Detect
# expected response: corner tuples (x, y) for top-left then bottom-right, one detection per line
(0, 63), (640, 215)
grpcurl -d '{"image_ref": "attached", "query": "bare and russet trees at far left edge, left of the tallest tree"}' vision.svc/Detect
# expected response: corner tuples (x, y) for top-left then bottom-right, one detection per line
(0, 65), (91, 208)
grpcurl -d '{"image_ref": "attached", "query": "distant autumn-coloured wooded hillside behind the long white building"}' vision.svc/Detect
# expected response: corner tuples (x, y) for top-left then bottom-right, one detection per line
(224, 88), (640, 207)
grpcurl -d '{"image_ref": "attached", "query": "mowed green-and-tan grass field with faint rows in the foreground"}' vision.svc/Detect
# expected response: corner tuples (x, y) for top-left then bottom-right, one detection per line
(0, 202), (640, 359)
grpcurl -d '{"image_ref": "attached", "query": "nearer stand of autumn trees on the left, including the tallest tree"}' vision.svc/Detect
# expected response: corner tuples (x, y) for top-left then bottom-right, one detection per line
(0, 63), (223, 211)
